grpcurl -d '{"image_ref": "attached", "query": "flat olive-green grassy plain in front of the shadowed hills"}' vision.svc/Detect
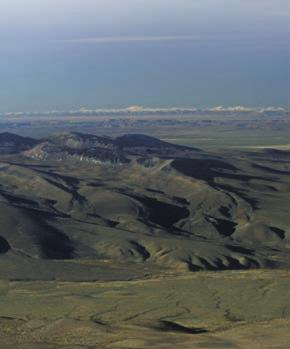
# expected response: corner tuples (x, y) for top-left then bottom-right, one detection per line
(0, 270), (290, 349)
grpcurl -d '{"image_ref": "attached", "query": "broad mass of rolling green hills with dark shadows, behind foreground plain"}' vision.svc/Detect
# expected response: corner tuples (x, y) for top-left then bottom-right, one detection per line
(0, 133), (290, 281)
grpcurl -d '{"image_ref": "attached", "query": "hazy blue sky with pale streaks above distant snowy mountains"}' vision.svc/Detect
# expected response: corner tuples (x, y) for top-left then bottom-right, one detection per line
(0, 0), (290, 112)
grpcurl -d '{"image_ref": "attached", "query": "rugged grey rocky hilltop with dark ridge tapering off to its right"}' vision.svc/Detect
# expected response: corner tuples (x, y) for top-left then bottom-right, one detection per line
(20, 132), (200, 164)
